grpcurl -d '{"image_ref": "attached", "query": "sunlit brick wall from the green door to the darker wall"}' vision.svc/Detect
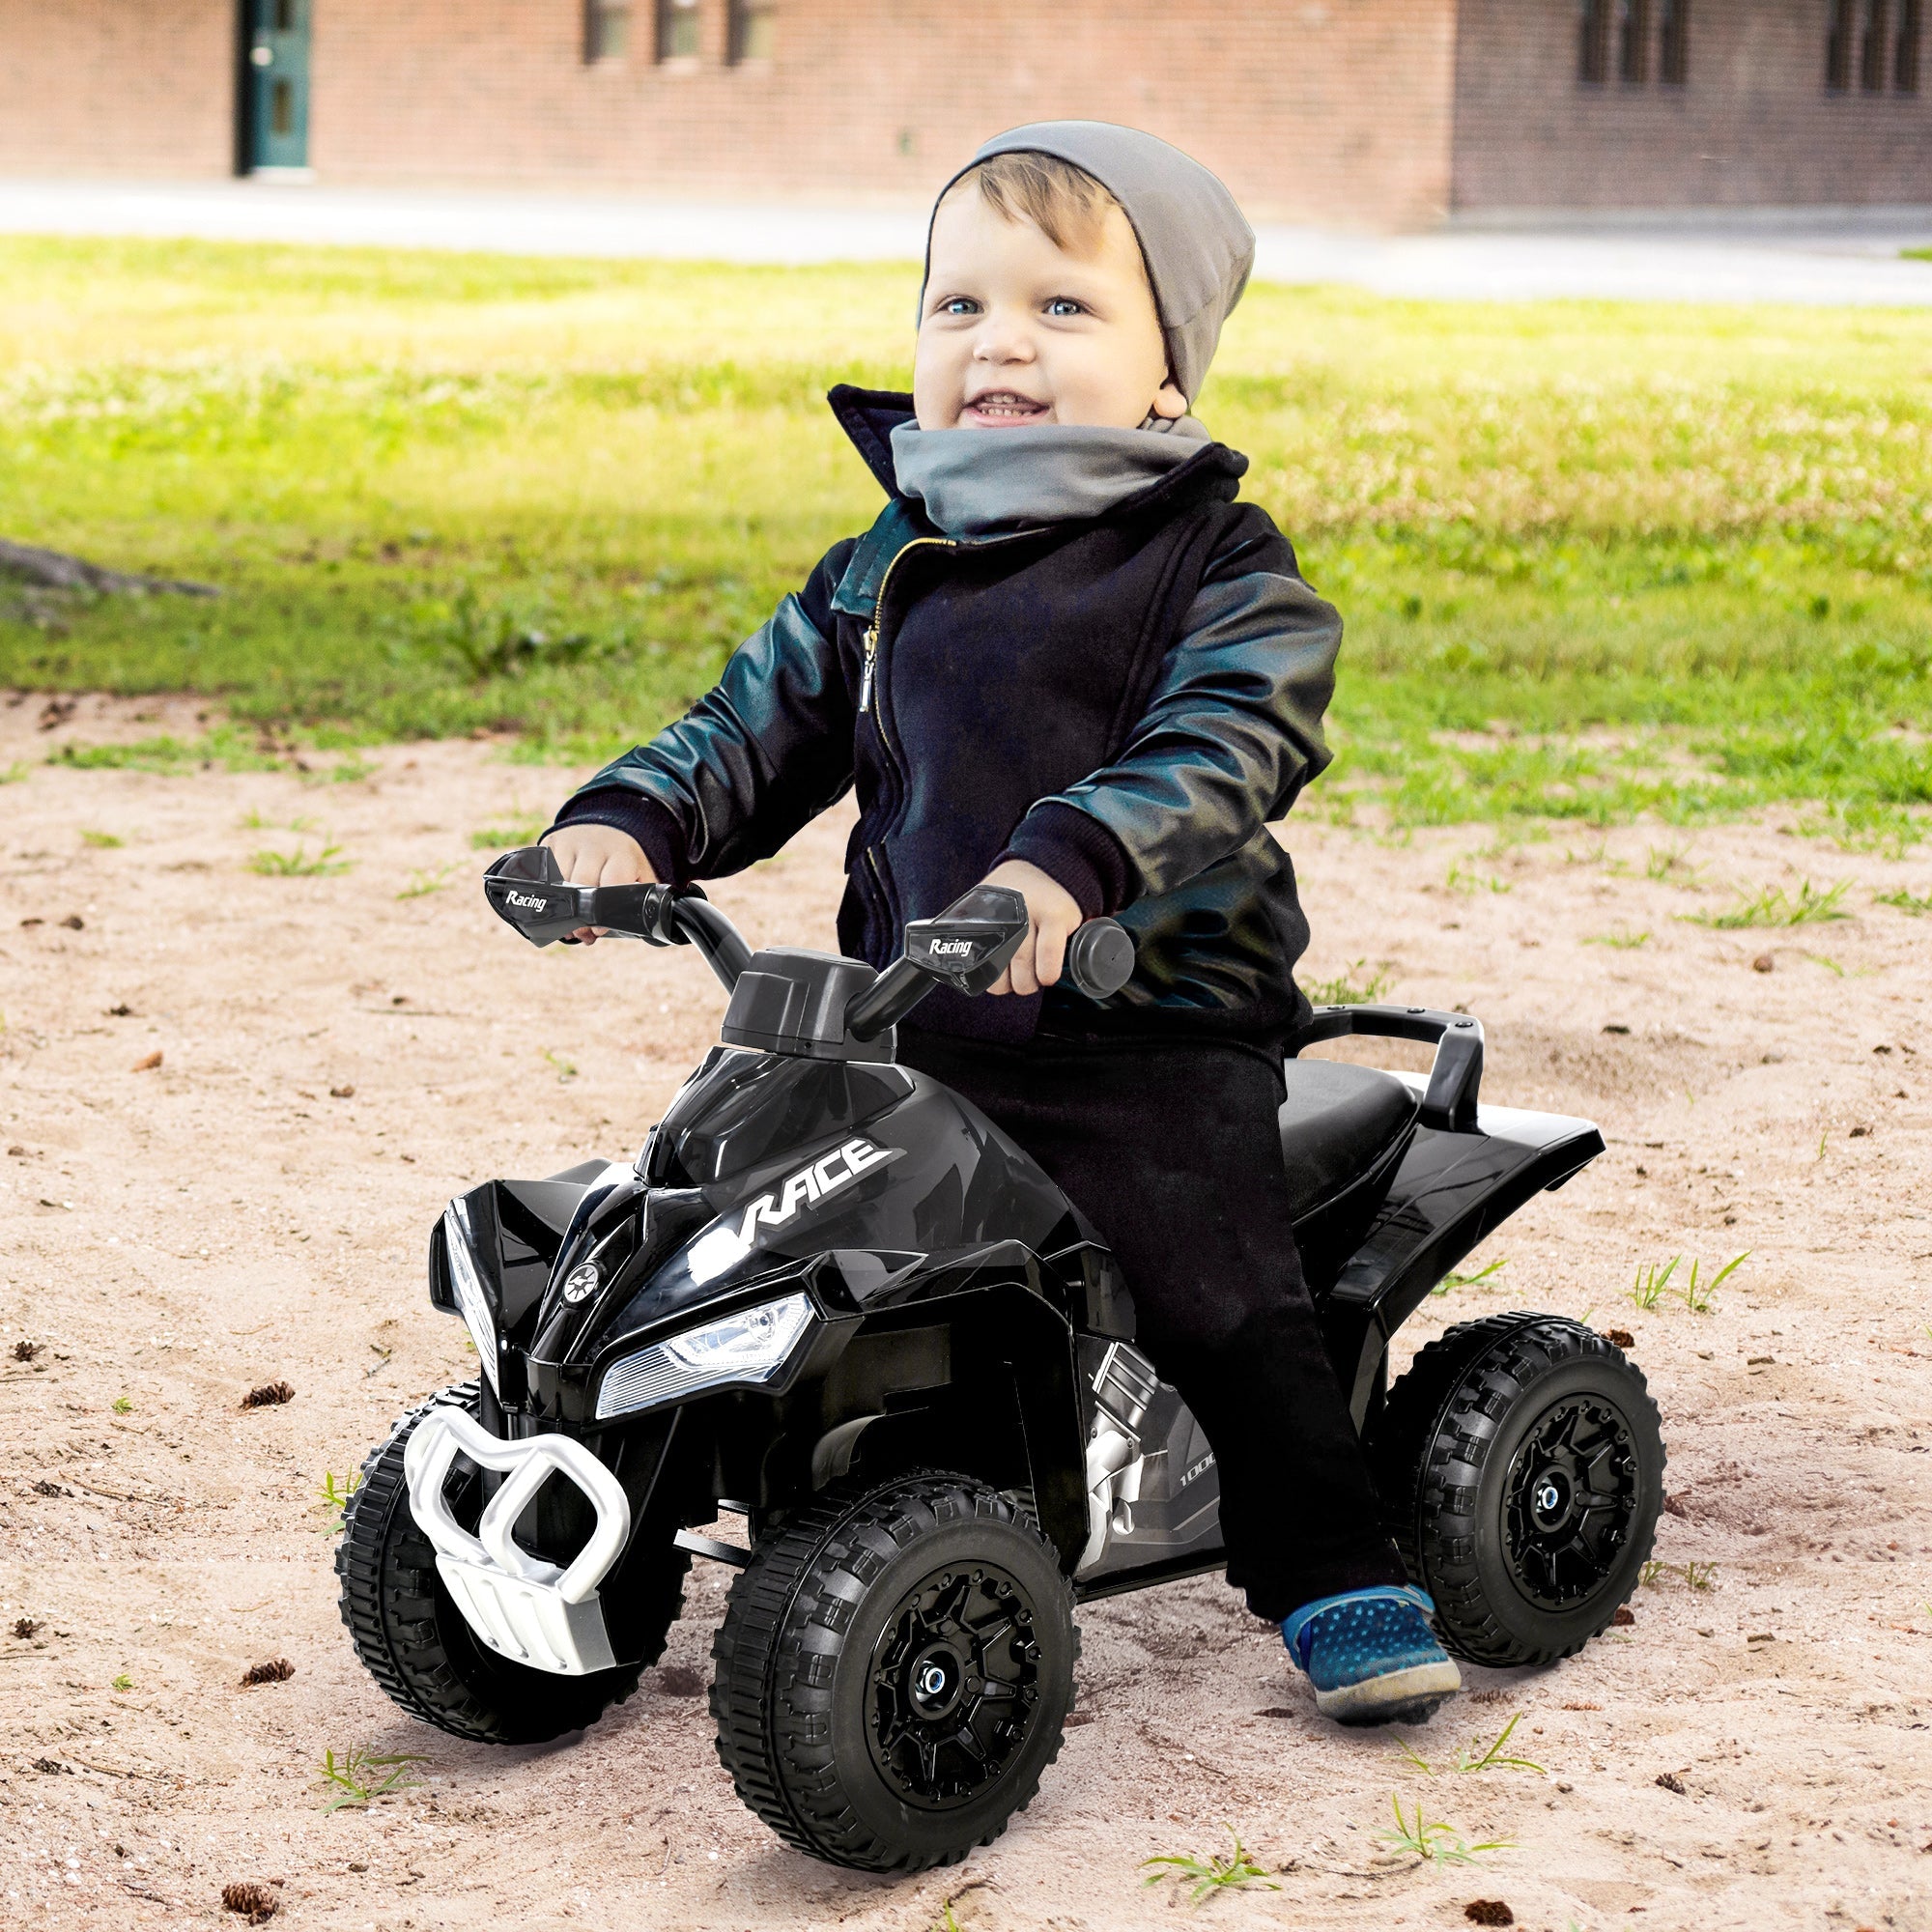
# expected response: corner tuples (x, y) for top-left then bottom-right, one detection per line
(311, 0), (1455, 224)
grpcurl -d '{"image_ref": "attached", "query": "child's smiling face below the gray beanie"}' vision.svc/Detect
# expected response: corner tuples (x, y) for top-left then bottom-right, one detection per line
(912, 182), (1188, 429)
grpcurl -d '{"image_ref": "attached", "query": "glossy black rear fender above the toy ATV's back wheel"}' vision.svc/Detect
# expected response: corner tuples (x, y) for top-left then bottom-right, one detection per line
(1321, 1076), (1604, 1428)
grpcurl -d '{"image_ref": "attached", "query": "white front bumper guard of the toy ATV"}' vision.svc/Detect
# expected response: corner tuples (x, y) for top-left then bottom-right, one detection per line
(402, 1408), (630, 1677)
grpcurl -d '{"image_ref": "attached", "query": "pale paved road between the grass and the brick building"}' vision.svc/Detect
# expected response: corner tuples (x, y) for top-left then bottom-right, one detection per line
(0, 180), (1932, 305)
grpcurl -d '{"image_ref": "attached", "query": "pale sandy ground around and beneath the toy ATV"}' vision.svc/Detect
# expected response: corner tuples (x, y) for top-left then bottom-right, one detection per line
(0, 696), (1932, 1932)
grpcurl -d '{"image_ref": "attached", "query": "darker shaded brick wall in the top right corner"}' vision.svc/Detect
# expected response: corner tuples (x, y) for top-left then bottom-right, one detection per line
(1453, 0), (1932, 209)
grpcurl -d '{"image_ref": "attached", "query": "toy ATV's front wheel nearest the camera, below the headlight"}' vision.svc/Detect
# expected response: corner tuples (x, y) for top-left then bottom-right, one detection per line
(711, 1474), (1080, 1872)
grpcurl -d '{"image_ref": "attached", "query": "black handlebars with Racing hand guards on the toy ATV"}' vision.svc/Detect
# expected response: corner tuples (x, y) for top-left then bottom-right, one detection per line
(483, 846), (1134, 1041)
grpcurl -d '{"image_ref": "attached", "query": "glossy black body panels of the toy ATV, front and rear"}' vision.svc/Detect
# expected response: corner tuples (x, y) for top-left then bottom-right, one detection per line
(431, 1010), (1602, 1598)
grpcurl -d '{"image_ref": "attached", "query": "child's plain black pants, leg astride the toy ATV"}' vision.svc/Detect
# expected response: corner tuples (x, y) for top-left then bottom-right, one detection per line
(898, 1026), (1405, 1621)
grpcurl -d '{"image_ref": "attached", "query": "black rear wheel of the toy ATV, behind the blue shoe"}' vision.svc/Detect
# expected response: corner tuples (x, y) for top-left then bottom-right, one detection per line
(1370, 1314), (1663, 1665)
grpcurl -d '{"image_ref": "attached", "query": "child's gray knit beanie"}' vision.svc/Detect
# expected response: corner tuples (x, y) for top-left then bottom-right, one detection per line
(920, 122), (1254, 404)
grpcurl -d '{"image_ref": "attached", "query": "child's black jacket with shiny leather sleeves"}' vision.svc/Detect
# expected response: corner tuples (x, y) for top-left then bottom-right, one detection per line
(558, 388), (1341, 1045)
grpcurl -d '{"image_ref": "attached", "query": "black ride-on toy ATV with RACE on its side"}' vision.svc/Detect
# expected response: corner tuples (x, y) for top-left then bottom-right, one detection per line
(338, 846), (1663, 1870)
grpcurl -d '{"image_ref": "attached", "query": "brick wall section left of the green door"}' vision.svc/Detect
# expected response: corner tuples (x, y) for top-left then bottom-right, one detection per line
(0, 0), (238, 176)
